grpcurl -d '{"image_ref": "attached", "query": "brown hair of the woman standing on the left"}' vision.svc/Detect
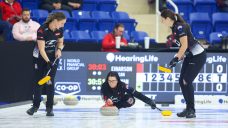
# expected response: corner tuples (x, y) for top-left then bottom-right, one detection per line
(44, 12), (66, 24)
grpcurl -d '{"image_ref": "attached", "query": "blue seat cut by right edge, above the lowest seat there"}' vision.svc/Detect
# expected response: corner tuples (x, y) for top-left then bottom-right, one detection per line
(212, 13), (228, 32)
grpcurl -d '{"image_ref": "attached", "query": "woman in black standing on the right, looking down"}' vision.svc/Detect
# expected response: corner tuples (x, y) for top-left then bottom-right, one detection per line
(161, 9), (206, 118)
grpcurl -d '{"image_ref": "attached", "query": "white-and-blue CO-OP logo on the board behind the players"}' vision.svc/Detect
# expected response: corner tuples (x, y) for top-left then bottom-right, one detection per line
(55, 82), (81, 95)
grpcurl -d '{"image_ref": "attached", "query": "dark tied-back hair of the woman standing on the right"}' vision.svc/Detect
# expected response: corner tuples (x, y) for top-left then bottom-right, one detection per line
(161, 9), (186, 23)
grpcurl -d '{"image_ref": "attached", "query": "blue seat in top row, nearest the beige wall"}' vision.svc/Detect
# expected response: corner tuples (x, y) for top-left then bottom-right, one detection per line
(98, 0), (117, 12)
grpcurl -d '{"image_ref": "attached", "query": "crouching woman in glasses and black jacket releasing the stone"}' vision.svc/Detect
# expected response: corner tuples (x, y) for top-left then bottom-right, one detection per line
(101, 71), (156, 109)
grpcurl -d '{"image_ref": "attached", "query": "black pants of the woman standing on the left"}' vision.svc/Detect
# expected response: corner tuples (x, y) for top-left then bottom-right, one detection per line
(33, 53), (58, 108)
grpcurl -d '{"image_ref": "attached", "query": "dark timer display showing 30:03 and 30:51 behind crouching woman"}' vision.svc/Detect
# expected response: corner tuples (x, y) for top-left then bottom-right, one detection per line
(87, 63), (135, 92)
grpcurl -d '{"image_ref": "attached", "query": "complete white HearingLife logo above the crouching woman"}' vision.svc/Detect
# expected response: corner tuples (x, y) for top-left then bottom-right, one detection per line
(106, 53), (158, 63)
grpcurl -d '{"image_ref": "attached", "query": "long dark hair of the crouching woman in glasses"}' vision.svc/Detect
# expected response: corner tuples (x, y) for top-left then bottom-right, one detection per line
(101, 71), (126, 95)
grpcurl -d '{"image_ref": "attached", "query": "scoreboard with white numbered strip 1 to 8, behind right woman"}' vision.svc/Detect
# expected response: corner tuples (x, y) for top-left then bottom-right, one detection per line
(136, 56), (228, 94)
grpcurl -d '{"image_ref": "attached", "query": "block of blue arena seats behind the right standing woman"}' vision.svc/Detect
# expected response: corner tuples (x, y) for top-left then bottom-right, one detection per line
(167, 0), (228, 43)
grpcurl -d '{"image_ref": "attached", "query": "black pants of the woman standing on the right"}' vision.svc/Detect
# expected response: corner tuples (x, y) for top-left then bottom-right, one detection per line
(179, 51), (206, 110)
